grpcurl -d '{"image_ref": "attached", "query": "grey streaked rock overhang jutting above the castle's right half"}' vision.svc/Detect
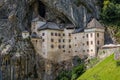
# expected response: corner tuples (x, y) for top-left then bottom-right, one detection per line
(41, 0), (101, 27)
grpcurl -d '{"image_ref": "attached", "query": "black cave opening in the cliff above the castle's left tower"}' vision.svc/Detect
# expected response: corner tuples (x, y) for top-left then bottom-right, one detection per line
(38, 1), (46, 18)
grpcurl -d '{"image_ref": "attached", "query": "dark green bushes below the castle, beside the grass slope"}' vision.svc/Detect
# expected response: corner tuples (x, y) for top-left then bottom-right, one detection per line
(56, 58), (86, 80)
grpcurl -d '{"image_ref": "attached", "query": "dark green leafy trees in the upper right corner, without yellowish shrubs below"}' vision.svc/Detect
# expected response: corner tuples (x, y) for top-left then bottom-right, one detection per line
(101, 0), (120, 26)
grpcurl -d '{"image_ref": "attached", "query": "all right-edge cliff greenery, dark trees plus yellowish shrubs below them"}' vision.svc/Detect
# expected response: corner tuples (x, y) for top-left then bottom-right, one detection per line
(101, 0), (120, 43)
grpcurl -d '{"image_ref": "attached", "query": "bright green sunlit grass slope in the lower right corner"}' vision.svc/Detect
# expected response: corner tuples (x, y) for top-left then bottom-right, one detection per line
(77, 55), (120, 80)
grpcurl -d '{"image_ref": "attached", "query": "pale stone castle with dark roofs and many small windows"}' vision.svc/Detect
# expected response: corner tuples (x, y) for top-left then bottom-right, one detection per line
(24, 18), (105, 61)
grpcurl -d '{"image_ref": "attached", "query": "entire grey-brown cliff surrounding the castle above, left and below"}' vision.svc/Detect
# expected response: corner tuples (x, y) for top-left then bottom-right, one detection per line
(0, 0), (101, 80)
